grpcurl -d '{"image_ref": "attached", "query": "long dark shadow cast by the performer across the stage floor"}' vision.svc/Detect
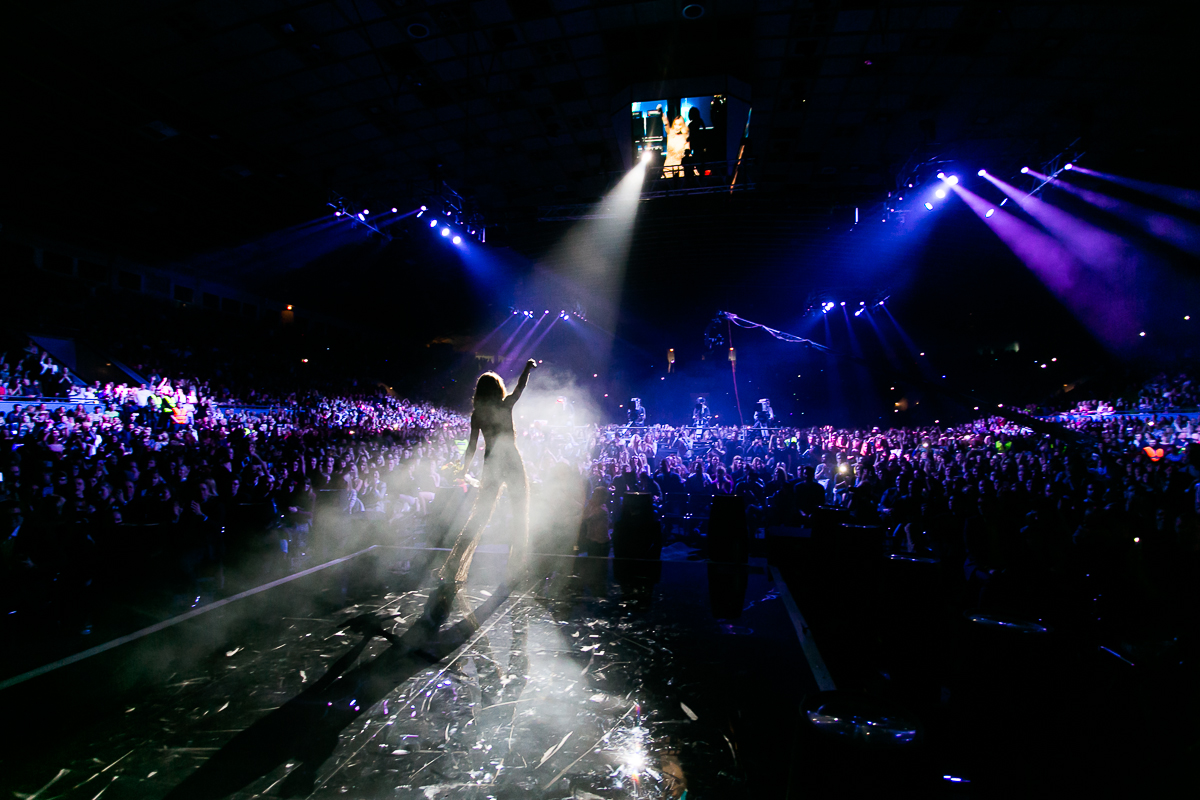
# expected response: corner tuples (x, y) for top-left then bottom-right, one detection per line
(167, 590), (509, 800)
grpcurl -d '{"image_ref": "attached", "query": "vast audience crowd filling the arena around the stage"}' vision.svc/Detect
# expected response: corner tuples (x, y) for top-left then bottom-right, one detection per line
(0, 331), (1200, 630)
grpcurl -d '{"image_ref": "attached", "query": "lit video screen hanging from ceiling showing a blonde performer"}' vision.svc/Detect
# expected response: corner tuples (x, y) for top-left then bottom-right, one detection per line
(631, 95), (730, 178)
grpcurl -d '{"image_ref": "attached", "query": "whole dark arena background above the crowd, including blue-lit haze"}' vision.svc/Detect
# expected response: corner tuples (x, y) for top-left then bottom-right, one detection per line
(0, 0), (1200, 425)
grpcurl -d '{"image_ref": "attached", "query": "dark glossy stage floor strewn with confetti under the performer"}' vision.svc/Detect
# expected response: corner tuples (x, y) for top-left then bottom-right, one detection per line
(0, 548), (815, 800)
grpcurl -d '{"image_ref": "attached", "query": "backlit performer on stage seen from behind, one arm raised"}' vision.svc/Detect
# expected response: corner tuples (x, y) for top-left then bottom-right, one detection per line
(434, 359), (538, 594)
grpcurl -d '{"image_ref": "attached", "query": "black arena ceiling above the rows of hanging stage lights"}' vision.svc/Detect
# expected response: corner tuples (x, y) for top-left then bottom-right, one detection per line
(2, 0), (1196, 266)
